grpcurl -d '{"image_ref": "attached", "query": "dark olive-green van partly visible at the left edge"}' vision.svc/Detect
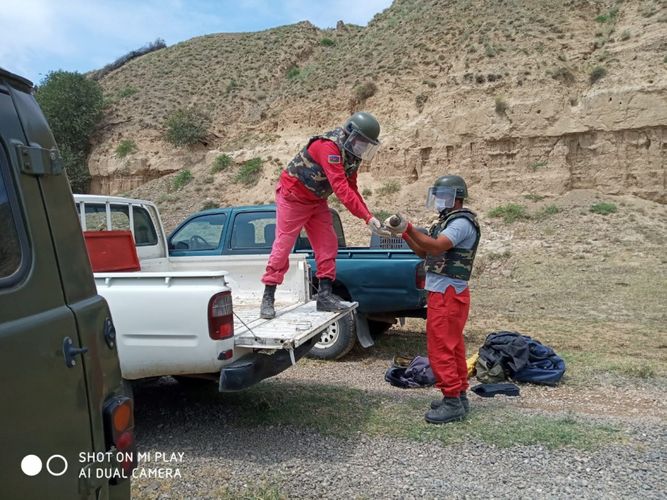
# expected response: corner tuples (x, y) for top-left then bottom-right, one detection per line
(0, 68), (134, 499)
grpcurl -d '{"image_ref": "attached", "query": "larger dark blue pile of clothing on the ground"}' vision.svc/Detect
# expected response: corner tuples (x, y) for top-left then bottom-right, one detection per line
(475, 331), (565, 385)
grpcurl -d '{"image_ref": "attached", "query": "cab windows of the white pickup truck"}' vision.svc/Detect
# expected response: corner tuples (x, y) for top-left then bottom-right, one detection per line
(81, 203), (157, 247)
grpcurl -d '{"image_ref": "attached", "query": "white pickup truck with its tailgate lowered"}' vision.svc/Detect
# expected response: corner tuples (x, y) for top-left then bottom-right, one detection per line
(74, 195), (356, 392)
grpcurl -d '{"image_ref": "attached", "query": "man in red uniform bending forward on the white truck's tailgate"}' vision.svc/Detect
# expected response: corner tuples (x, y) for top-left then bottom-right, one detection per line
(260, 112), (386, 318)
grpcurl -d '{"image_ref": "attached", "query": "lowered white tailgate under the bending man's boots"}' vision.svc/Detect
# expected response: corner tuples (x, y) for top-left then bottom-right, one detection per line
(234, 300), (358, 349)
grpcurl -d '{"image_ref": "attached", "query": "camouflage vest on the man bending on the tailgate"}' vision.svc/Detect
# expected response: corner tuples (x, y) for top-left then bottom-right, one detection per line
(286, 127), (361, 199)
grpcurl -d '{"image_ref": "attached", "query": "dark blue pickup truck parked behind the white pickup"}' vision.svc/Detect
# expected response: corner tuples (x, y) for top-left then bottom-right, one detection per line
(168, 205), (426, 359)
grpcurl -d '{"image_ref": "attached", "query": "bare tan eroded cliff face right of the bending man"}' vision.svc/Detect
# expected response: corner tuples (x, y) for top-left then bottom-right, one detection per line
(372, 88), (667, 203)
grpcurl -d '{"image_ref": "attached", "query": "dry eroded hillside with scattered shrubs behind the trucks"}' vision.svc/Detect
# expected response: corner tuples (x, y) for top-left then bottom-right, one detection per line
(89, 0), (667, 225)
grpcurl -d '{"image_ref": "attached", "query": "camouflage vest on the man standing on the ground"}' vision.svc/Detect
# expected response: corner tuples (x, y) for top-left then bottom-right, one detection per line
(425, 208), (481, 281)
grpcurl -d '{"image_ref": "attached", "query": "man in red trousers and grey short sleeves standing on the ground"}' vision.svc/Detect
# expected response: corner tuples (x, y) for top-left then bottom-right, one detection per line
(385, 175), (480, 424)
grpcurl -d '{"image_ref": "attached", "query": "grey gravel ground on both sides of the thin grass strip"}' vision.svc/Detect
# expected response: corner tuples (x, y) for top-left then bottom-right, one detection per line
(132, 357), (667, 499)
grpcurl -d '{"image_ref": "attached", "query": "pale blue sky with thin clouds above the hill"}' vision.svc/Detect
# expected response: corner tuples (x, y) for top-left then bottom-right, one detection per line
(0, 0), (391, 84)
